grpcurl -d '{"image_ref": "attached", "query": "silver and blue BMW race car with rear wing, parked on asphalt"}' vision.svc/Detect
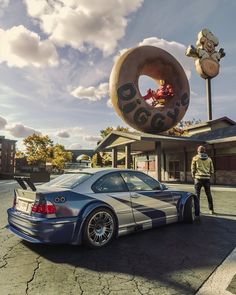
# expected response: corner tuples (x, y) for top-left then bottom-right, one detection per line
(8, 168), (198, 248)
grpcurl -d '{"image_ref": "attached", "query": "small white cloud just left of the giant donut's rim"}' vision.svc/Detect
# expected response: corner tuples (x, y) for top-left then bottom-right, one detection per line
(70, 83), (109, 101)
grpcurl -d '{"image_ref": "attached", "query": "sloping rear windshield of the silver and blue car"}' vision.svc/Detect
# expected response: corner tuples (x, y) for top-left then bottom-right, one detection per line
(47, 173), (93, 188)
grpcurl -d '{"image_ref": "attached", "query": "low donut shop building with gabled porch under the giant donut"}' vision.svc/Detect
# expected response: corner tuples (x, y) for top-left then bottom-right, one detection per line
(95, 117), (236, 185)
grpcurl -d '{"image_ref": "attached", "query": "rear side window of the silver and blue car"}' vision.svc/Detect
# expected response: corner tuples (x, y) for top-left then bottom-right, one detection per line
(92, 172), (127, 193)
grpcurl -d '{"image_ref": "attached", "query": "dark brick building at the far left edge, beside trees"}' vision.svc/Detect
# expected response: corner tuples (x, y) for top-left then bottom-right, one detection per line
(0, 136), (16, 179)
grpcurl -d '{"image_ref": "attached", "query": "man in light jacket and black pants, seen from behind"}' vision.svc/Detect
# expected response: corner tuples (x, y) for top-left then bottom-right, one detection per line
(191, 145), (214, 216)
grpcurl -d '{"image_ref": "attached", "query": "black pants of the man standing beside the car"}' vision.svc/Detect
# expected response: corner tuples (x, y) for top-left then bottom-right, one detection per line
(194, 178), (213, 216)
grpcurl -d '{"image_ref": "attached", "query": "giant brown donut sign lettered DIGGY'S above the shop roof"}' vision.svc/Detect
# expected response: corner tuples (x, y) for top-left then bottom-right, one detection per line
(109, 46), (190, 134)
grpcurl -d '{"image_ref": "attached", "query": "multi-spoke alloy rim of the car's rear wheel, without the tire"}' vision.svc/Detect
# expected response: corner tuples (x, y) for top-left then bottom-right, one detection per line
(87, 211), (114, 246)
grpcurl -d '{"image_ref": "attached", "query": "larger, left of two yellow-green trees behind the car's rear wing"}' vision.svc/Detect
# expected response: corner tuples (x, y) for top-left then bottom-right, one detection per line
(23, 133), (53, 165)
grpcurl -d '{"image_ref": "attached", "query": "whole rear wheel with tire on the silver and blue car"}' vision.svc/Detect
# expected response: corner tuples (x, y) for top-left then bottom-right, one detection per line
(83, 208), (116, 248)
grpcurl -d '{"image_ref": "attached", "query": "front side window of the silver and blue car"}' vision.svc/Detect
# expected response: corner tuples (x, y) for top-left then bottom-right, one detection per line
(121, 172), (161, 192)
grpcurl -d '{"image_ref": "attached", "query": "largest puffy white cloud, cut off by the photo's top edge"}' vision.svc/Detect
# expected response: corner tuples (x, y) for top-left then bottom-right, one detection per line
(25, 0), (143, 55)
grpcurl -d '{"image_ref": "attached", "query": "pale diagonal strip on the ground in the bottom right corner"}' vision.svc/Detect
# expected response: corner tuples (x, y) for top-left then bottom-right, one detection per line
(196, 248), (236, 295)
